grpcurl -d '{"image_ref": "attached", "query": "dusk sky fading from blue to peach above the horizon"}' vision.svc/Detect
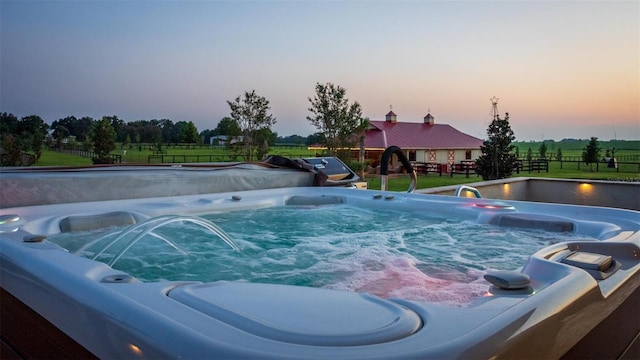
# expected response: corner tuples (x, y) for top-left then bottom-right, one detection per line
(0, 0), (640, 141)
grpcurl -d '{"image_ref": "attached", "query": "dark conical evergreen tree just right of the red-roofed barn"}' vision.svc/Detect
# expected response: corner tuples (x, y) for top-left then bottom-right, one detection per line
(476, 113), (517, 180)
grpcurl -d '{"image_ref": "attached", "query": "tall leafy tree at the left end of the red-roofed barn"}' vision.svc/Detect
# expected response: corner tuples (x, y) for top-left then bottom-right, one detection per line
(307, 83), (369, 161)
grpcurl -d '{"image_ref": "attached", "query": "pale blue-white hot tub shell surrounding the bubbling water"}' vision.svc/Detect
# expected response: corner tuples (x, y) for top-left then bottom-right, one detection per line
(0, 167), (640, 359)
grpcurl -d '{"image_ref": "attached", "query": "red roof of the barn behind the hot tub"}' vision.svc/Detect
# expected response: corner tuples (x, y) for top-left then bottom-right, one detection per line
(365, 120), (482, 149)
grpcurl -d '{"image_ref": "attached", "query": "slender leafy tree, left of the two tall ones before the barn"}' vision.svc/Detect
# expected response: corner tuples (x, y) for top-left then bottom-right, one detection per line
(227, 90), (276, 161)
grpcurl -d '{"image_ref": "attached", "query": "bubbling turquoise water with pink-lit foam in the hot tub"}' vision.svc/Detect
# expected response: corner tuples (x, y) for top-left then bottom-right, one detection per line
(49, 205), (584, 306)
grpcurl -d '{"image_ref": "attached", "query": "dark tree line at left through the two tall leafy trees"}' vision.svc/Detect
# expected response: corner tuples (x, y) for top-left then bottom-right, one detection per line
(0, 83), (368, 166)
